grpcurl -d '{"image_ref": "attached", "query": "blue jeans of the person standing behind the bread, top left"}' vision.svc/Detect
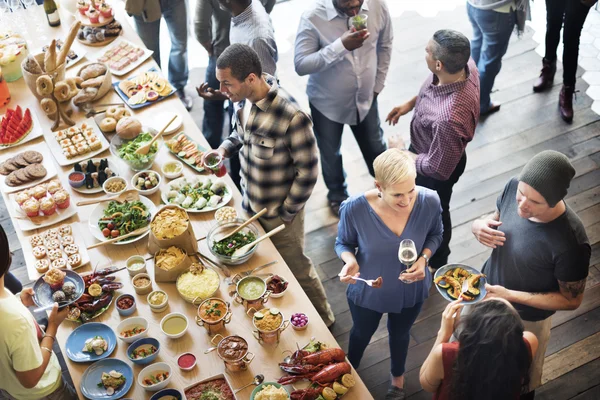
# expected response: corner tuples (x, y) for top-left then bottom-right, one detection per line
(133, 0), (189, 90)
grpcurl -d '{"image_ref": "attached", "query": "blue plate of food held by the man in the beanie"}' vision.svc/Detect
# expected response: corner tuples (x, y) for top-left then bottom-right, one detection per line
(434, 264), (487, 304)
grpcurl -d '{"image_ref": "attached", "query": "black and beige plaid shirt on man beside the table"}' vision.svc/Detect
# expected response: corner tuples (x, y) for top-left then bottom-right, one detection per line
(221, 76), (319, 221)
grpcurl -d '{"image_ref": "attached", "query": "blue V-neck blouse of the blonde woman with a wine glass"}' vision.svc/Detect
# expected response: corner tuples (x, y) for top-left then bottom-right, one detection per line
(335, 186), (443, 313)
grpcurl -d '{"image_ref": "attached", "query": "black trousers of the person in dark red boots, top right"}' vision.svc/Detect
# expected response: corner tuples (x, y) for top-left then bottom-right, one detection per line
(544, 0), (591, 86)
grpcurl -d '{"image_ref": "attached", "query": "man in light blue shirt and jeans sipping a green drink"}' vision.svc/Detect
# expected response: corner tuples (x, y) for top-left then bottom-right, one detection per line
(294, 0), (393, 215)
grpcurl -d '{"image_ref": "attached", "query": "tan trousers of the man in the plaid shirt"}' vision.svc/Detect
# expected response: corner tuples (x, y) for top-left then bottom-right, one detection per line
(259, 209), (335, 326)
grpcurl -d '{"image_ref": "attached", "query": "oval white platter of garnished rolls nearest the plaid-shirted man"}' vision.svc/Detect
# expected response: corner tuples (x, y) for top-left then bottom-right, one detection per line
(160, 176), (233, 213)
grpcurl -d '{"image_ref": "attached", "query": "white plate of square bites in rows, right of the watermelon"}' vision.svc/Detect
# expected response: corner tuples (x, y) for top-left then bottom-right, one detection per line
(44, 118), (109, 167)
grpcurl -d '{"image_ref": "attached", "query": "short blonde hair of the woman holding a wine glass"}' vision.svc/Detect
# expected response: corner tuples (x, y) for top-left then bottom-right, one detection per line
(373, 148), (417, 188)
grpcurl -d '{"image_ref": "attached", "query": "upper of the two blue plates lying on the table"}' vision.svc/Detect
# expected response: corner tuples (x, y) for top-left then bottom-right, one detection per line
(65, 322), (117, 362)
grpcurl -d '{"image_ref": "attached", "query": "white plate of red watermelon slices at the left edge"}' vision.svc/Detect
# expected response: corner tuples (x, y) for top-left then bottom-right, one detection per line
(0, 105), (43, 151)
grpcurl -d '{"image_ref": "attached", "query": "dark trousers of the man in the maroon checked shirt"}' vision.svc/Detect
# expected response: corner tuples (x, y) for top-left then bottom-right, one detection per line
(409, 146), (467, 269)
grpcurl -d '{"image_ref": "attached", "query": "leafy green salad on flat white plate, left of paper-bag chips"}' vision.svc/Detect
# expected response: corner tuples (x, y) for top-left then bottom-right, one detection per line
(98, 201), (150, 238)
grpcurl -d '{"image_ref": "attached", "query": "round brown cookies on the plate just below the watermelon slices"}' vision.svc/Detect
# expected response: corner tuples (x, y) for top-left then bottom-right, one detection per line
(0, 150), (48, 187)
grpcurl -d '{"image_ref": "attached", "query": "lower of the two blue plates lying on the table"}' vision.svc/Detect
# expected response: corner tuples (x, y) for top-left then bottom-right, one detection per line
(80, 358), (134, 400)
